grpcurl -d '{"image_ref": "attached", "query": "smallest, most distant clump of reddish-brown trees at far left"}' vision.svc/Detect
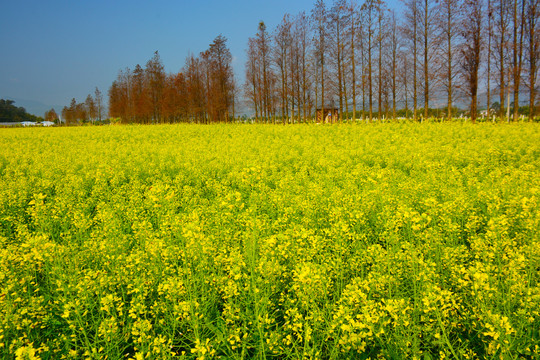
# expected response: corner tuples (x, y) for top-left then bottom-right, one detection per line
(61, 87), (104, 125)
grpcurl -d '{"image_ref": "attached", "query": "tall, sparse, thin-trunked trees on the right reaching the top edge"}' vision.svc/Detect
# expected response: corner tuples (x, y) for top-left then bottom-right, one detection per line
(244, 0), (540, 121)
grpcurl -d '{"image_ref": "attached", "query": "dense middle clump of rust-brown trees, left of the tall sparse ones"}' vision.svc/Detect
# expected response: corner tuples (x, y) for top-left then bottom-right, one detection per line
(109, 35), (236, 124)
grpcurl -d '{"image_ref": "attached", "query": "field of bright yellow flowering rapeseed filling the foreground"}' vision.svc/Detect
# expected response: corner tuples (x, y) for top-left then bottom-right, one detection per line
(0, 124), (540, 359)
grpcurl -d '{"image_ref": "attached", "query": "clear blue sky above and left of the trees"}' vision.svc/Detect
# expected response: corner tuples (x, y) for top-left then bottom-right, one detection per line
(0, 0), (400, 115)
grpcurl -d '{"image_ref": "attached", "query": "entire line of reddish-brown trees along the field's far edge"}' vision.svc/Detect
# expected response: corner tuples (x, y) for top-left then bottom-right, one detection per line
(62, 0), (540, 124)
